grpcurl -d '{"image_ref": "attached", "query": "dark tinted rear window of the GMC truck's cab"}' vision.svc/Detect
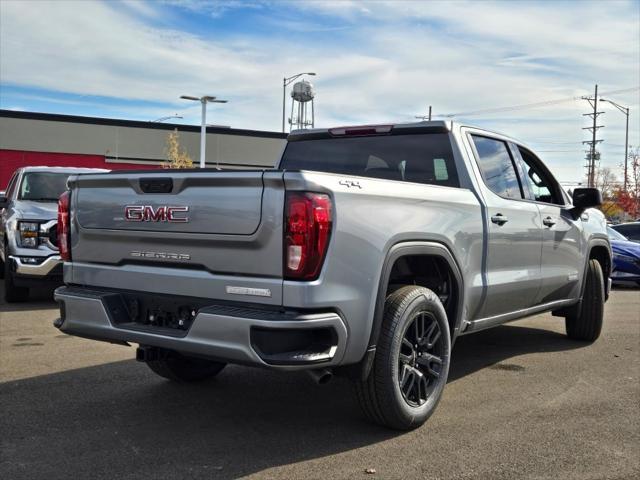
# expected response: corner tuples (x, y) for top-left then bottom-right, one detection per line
(280, 133), (460, 187)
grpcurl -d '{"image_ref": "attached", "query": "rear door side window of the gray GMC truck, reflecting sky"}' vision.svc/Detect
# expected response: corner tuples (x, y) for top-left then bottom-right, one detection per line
(471, 135), (524, 199)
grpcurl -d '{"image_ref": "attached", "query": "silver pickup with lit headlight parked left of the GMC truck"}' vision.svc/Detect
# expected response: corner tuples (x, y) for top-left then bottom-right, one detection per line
(0, 167), (108, 302)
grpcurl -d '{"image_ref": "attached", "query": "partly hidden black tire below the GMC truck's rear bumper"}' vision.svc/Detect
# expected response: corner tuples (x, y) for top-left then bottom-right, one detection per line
(146, 351), (226, 383)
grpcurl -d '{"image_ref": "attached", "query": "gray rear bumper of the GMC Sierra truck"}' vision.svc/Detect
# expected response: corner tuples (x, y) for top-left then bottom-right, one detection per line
(54, 287), (347, 370)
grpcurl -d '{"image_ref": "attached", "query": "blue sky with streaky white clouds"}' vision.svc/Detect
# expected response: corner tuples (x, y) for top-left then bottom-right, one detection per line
(0, 0), (640, 181)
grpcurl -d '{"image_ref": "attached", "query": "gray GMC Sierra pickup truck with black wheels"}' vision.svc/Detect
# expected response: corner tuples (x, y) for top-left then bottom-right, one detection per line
(55, 122), (611, 429)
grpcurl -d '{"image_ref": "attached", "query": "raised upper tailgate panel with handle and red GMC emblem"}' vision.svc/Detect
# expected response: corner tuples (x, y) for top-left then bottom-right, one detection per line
(76, 172), (263, 235)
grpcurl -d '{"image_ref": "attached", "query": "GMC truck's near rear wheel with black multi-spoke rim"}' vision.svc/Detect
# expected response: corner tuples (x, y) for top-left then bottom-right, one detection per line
(355, 286), (451, 430)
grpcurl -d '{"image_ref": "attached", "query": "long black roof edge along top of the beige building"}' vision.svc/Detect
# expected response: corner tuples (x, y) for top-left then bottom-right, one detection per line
(0, 109), (287, 140)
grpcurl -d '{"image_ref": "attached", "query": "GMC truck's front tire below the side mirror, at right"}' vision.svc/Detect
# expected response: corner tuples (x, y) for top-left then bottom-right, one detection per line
(565, 259), (605, 342)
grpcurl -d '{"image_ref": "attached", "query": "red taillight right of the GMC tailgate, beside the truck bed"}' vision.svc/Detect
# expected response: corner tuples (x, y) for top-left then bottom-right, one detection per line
(284, 192), (332, 280)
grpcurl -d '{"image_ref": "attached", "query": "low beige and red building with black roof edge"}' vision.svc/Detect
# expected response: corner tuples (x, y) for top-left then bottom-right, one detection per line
(0, 110), (285, 190)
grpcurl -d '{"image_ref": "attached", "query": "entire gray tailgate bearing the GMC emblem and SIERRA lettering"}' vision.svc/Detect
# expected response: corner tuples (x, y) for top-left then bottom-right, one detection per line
(65, 170), (284, 303)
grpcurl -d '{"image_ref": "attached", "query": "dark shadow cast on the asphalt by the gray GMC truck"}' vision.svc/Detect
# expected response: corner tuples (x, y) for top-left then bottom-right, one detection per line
(0, 316), (585, 479)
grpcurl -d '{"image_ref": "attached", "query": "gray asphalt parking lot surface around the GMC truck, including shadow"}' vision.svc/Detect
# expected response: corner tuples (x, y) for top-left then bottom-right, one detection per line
(0, 289), (640, 479)
